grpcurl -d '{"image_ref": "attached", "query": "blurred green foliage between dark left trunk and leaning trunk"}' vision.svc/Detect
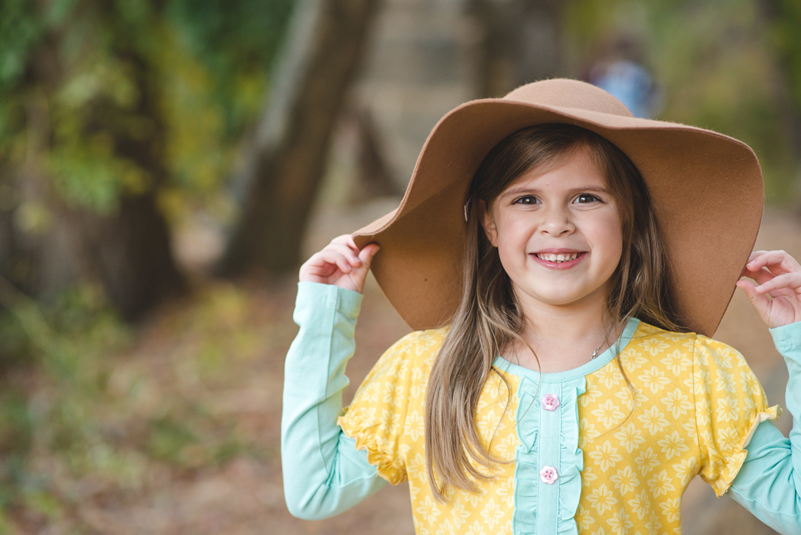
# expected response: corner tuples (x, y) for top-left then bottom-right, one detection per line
(150, 0), (294, 220)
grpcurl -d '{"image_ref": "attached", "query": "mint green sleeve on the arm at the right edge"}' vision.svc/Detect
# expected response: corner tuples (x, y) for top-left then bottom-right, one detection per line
(729, 322), (801, 534)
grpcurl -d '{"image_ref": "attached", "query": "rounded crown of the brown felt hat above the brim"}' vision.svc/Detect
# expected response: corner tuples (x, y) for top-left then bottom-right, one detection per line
(503, 79), (634, 117)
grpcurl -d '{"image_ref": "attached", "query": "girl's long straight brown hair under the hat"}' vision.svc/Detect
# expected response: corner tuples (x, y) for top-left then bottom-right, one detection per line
(425, 124), (681, 501)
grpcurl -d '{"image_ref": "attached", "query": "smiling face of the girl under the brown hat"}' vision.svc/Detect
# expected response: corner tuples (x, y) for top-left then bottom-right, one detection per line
(483, 148), (623, 314)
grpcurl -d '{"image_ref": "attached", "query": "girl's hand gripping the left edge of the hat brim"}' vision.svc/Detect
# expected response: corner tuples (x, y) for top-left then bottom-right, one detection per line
(298, 234), (379, 293)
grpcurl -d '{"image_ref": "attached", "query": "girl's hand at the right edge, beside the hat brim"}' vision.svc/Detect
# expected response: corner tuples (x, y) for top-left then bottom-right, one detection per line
(737, 251), (801, 328)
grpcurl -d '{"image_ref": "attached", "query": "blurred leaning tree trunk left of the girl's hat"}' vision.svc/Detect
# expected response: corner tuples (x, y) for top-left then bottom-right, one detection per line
(218, 0), (378, 277)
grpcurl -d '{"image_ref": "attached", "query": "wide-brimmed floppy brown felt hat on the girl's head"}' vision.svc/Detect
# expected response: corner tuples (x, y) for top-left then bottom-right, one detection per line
(353, 80), (763, 336)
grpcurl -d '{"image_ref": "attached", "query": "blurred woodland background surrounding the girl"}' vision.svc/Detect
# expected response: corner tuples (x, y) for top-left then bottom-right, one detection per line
(0, 0), (801, 534)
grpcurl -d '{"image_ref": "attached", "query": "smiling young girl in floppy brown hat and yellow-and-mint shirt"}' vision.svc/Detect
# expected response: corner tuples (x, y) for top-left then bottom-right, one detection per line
(282, 80), (801, 535)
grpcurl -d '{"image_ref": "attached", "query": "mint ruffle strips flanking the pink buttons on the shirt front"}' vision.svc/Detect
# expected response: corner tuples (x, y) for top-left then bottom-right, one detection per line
(513, 377), (586, 535)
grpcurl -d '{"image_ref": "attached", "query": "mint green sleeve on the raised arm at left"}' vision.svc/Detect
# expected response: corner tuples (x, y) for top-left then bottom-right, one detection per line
(281, 282), (387, 520)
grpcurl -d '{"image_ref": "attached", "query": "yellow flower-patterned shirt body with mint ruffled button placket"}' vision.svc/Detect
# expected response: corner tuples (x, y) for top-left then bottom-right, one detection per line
(339, 319), (779, 535)
